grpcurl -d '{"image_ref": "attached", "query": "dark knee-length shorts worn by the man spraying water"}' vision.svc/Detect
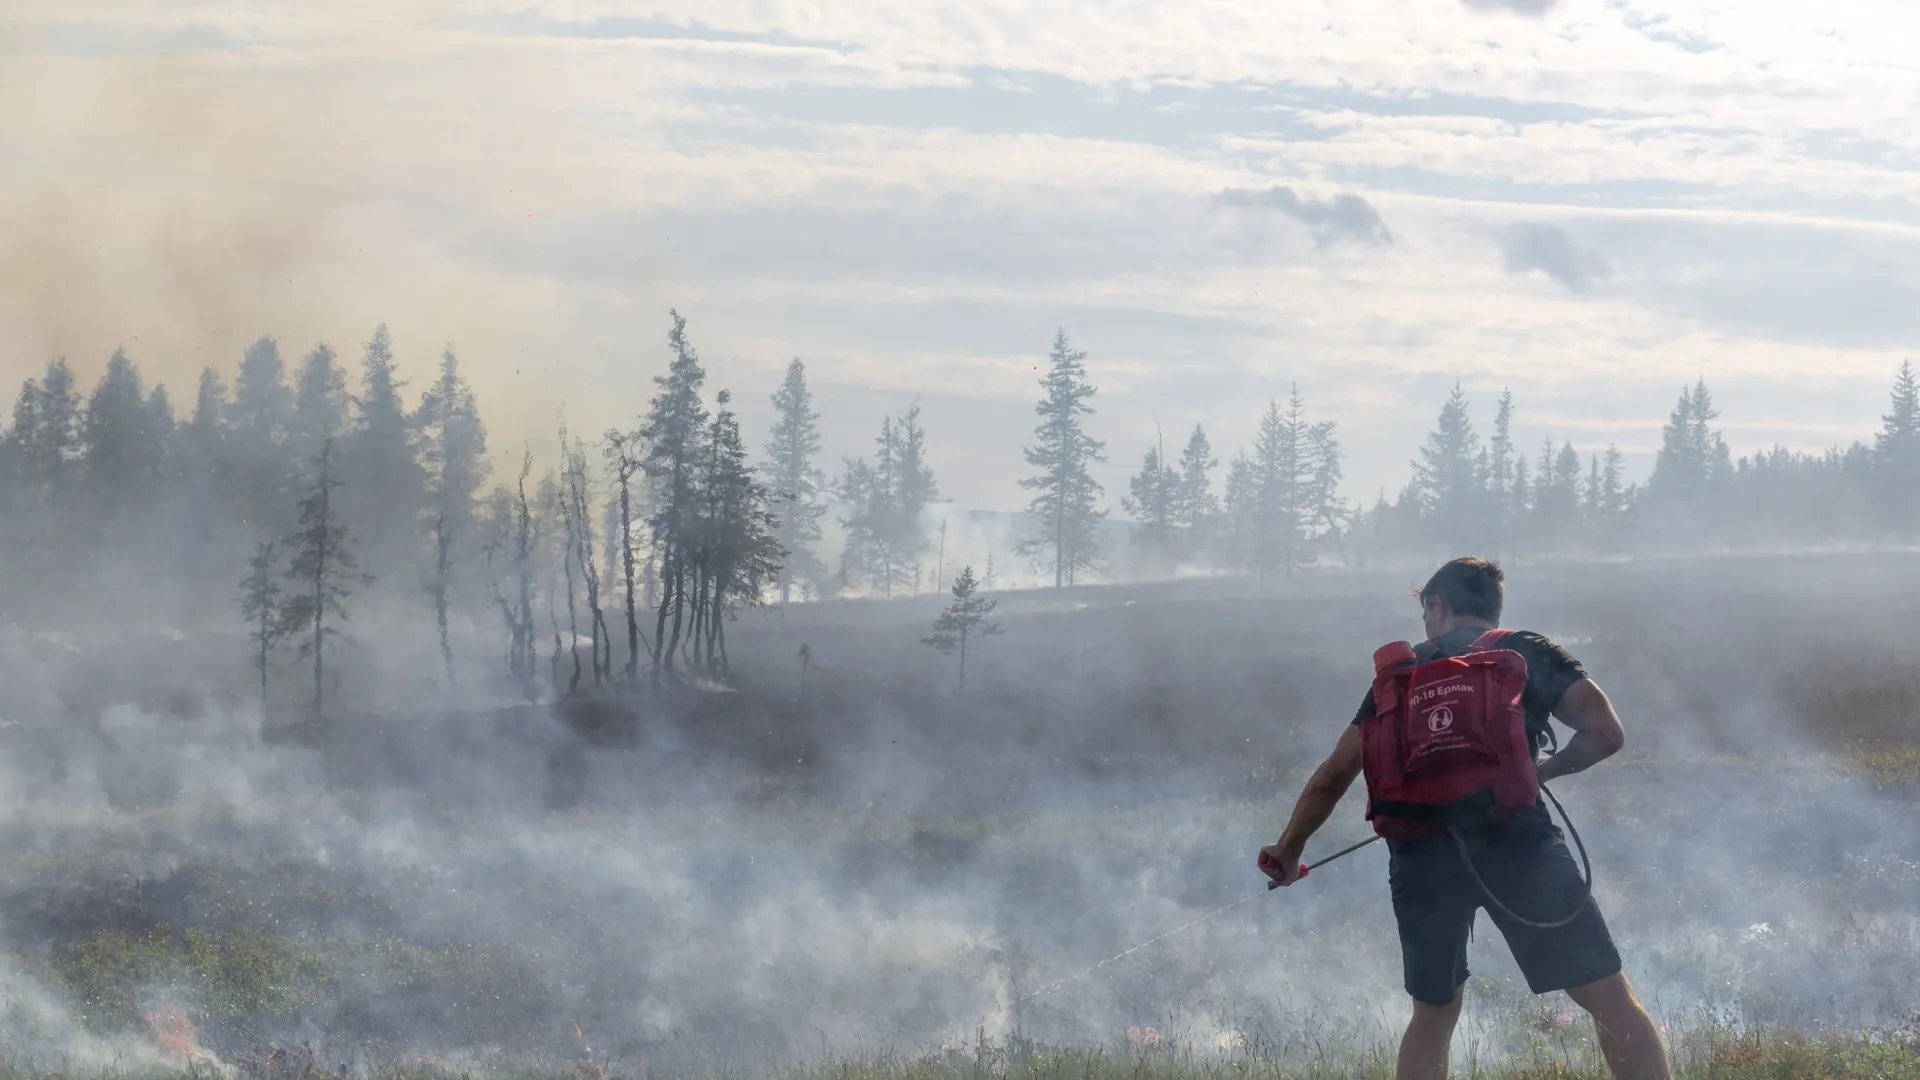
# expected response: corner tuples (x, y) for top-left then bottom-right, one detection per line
(1388, 809), (1620, 1005)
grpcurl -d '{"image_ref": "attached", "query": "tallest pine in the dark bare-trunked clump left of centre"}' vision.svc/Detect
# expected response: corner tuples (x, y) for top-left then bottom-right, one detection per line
(639, 311), (707, 673)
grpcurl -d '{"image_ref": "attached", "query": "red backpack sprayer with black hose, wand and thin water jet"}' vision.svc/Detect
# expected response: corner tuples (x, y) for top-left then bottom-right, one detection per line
(1002, 630), (1594, 1011)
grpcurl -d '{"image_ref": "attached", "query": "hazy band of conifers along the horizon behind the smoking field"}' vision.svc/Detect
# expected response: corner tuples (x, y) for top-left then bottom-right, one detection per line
(0, 313), (1920, 705)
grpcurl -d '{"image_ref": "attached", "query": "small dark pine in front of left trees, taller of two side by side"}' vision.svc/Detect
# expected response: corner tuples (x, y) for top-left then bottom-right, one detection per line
(280, 440), (372, 717)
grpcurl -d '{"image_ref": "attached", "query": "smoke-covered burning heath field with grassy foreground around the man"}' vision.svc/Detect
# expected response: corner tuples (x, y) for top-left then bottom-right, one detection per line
(0, 555), (1920, 1080)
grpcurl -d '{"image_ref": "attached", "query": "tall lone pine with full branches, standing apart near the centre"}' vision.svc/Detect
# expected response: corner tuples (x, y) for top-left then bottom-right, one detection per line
(1016, 331), (1106, 588)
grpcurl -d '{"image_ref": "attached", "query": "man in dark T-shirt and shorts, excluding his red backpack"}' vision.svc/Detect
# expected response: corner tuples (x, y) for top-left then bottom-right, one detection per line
(1261, 557), (1670, 1080)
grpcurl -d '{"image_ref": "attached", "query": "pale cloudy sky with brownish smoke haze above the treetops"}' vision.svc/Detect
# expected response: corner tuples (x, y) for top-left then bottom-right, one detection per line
(0, 0), (1920, 513)
